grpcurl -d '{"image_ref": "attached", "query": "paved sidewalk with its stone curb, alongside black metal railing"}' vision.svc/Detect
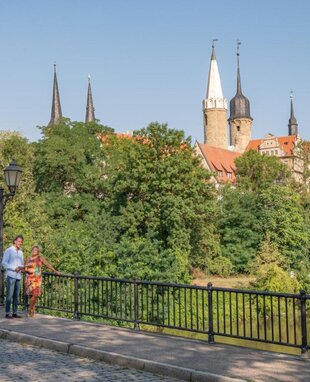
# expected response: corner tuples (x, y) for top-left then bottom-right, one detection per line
(0, 309), (310, 382)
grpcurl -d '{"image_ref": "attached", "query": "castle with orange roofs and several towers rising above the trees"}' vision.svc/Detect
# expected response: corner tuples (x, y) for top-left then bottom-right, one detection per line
(194, 42), (304, 183)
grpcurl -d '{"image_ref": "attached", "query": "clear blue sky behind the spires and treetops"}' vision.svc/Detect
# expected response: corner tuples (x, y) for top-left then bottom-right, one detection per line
(0, 0), (310, 141)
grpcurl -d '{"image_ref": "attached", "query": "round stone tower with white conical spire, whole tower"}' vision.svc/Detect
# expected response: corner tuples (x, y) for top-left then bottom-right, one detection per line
(203, 40), (227, 149)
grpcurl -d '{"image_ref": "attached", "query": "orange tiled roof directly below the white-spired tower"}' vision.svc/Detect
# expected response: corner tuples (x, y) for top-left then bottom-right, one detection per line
(198, 143), (242, 182)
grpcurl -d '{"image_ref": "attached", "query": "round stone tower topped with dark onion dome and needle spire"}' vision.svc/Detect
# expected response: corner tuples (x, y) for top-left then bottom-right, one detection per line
(228, 41), (253, 153)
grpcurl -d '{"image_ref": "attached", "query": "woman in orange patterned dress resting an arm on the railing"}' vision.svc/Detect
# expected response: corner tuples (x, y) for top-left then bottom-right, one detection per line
(25, 245), (60, 317)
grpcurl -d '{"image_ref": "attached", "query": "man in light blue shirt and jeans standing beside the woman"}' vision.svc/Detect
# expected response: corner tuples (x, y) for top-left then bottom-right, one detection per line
(2, 235), (24, 318)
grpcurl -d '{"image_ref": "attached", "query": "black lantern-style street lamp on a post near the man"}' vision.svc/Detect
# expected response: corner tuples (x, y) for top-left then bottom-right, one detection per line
(0, 160), (23, 304)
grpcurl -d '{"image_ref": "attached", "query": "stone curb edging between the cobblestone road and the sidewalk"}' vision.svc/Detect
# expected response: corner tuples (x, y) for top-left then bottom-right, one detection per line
(0, 329), (246, 382)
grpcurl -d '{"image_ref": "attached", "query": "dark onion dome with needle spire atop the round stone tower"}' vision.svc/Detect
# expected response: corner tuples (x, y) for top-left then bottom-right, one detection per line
(230, 40), (252, 119)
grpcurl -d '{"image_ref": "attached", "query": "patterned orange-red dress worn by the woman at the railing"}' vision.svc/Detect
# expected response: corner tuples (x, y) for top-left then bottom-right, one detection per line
(25, 256), (42, 296)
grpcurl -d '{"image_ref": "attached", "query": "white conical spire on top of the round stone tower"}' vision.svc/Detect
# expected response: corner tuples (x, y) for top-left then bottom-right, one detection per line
(204, 40), (227, 110)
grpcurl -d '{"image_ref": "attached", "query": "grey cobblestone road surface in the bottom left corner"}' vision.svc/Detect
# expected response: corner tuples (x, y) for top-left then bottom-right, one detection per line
(0, 340), (178, 382)
